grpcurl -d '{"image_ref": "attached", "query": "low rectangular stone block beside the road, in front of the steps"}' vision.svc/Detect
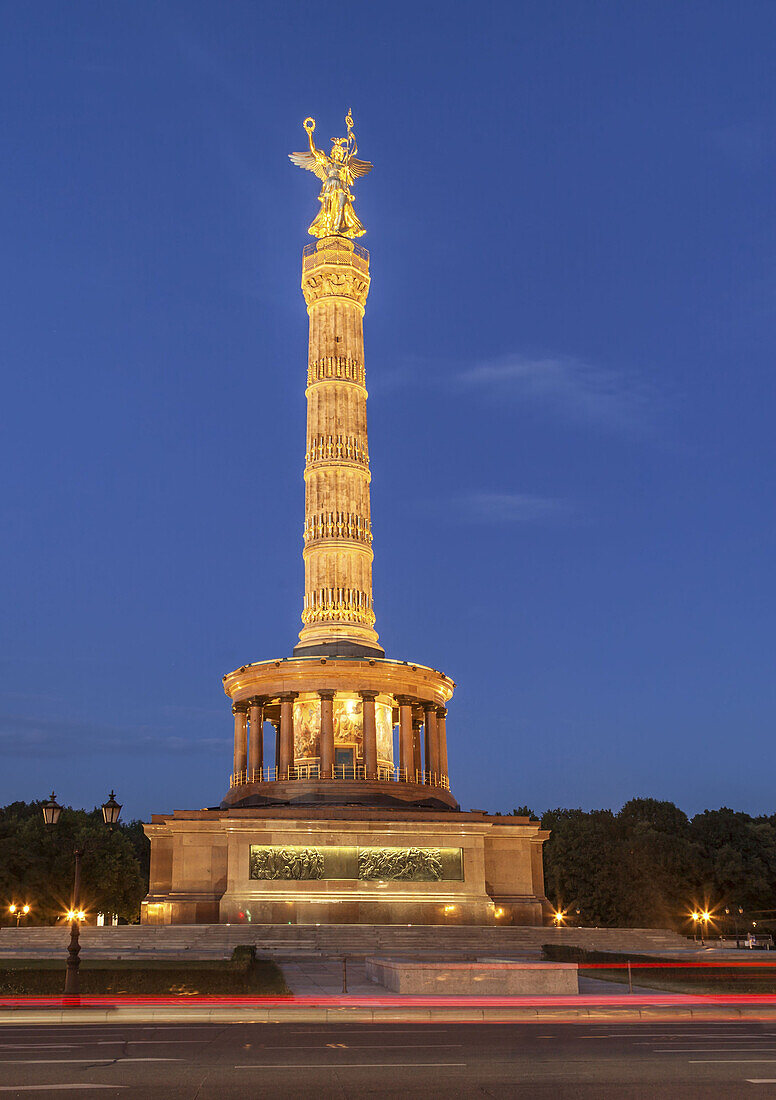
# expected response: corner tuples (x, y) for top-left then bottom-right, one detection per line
(367, 958), (579, 997)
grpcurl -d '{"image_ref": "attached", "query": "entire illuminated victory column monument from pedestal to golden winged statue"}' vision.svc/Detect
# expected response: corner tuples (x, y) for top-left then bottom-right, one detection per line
(142, 112), (547, 924)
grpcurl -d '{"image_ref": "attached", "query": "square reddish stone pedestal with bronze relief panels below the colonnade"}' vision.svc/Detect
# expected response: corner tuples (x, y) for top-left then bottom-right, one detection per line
(142, 806), (546, 925)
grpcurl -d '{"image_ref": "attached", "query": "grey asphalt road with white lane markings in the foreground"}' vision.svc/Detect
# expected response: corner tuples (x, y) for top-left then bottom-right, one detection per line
(0, 1021), (776, 1100)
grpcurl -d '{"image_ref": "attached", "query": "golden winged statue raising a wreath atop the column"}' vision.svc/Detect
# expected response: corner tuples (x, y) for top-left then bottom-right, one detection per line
(288, 111), (372, 237)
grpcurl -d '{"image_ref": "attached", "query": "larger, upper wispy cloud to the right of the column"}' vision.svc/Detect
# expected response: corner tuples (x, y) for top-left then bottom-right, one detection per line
(458, 355), (654, 431)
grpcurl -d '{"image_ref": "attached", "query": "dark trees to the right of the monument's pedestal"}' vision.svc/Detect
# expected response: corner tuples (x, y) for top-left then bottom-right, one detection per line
(542, 799), (776, 933)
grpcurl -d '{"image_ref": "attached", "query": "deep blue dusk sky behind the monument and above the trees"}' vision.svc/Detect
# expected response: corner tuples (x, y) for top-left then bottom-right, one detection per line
(0, 0), (776, 817)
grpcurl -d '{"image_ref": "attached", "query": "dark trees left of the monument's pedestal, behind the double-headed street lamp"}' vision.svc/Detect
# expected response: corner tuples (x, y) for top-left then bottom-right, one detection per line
(0, 802), (150, 924)
